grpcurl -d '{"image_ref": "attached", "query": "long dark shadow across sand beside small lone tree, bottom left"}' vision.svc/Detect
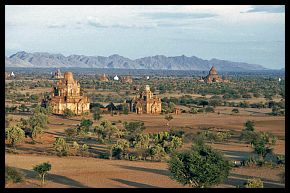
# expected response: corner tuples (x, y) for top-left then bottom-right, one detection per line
(15, 168), (89, 188)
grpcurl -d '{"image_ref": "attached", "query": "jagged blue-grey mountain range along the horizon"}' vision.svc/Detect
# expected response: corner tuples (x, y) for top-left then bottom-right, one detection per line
(5, 51), (267, 72)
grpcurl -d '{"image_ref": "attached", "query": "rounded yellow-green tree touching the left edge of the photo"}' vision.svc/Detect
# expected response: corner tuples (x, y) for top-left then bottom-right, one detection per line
(5, 126), (25, 148)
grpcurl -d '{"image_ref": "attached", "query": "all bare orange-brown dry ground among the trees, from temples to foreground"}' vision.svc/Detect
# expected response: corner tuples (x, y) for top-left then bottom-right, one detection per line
(5, 107), (285, 188)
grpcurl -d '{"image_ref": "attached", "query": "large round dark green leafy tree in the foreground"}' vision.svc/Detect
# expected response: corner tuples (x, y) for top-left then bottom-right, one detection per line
(168, 145), (231, 188)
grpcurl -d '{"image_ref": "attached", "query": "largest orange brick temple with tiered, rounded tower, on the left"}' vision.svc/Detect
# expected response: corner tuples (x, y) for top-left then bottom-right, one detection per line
(49, 72), (90, 115)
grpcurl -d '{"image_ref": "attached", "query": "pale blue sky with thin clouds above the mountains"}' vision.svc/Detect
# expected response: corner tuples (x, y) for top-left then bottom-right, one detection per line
(5, 5), (285, 69)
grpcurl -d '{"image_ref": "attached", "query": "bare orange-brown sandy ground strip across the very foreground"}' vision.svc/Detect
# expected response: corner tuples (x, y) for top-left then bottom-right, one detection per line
(5, 154), (284, 188)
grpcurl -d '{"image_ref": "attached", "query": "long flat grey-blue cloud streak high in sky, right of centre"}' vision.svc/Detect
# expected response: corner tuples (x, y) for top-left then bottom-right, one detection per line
(143, 12), (217, 19)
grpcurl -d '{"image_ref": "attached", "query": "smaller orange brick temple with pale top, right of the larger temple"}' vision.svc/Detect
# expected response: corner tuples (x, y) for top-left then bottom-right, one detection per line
(126, 85), (161, 114)
